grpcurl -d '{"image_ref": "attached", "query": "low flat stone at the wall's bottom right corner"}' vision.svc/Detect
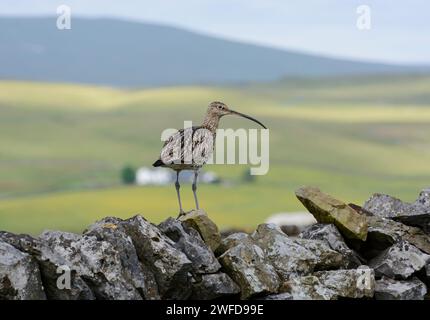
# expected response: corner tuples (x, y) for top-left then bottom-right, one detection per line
(375, 277), (427, 300)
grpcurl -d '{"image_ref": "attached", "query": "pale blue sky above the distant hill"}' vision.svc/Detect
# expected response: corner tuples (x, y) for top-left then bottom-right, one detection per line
(0, 0), (430, 64)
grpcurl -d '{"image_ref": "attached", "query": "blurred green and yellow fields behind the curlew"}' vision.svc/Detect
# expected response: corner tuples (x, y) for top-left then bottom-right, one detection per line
(0, 76), (430, 234)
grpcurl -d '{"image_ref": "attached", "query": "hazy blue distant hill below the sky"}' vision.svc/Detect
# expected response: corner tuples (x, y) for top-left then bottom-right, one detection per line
(0, 17), (429, 87)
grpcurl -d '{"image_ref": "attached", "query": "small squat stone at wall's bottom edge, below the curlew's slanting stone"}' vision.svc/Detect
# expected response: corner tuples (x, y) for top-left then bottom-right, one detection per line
(191, 273), (240, 300)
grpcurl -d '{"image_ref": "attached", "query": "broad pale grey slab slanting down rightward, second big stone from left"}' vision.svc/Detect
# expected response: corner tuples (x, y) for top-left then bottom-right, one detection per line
(39, 231), (142, 300)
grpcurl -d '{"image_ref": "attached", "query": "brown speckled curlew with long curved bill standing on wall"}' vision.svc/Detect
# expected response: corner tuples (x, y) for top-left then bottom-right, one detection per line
(153, 101), (266, 216)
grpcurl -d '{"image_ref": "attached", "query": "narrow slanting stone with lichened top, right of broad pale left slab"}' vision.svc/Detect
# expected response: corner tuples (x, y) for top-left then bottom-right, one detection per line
(85, 217), (160, 300)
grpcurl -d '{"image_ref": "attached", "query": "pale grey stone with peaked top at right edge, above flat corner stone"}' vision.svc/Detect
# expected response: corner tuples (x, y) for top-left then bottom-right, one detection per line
(369, 241), (430, 279)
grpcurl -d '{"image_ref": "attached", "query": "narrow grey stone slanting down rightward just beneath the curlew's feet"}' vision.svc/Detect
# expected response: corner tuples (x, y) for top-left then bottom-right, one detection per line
(158, 218), (221, 273)
